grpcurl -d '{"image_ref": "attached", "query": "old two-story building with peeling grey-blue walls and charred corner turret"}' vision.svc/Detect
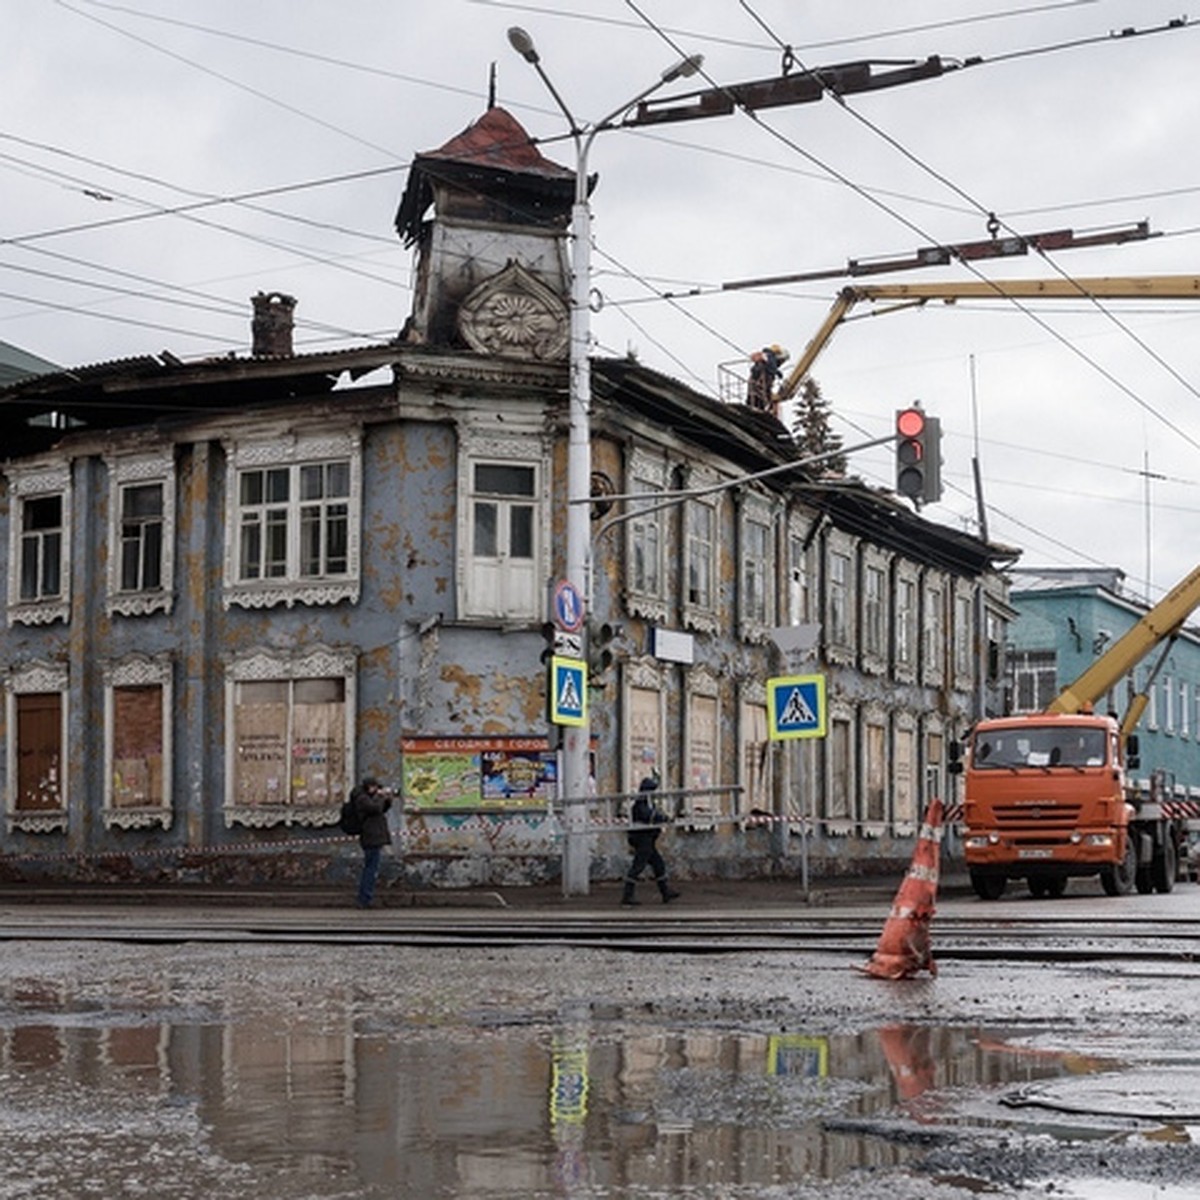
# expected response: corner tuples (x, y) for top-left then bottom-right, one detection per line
(0, 108), (1010, 886)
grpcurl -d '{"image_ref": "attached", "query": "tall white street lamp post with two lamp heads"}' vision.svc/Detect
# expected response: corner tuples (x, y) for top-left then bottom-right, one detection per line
(509, 26), (703, 895)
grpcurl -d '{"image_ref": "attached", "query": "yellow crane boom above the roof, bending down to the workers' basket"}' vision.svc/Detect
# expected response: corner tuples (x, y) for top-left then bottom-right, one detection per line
(774, 275), (1200, 406)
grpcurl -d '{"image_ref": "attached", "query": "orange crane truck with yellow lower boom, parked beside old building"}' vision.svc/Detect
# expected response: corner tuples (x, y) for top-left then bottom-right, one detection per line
(950, 566), (1200, 900)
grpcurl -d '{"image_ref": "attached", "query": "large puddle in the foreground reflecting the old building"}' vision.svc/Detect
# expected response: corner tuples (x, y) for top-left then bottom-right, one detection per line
(0, 980), (1113, 1200)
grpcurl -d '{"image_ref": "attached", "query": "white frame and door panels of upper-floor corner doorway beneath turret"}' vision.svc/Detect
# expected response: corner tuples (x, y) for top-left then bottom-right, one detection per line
(457, 428), (552, 622)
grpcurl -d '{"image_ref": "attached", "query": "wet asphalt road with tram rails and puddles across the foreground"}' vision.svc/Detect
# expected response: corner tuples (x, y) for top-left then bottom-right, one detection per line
(0, 883), (1200, 1200)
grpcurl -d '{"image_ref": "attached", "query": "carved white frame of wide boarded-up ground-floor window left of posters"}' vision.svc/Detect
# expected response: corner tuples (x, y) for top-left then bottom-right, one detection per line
(224, 646), (358, 829)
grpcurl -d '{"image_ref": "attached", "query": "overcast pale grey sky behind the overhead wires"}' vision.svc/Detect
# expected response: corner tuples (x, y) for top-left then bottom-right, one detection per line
(0, 0), (1200, 599)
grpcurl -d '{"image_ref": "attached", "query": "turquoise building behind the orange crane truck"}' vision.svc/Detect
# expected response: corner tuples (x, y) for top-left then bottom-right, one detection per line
(1008, 568), (1200, 816)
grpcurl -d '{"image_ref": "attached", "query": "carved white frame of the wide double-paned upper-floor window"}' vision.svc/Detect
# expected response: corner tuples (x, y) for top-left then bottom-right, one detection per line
(224, 430), (362, 608)
